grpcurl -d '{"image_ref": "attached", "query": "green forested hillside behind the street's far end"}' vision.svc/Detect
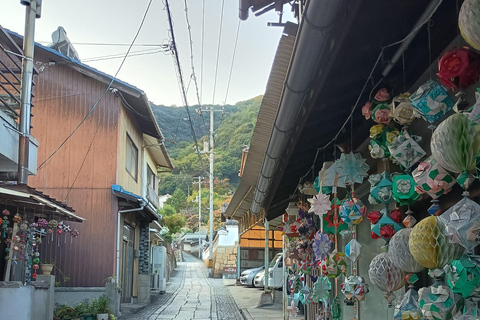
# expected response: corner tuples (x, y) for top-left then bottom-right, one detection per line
(152, 96), (262, 235)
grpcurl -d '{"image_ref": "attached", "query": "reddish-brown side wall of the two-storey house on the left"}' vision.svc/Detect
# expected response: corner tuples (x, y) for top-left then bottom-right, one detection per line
(29, 55), (121, 286)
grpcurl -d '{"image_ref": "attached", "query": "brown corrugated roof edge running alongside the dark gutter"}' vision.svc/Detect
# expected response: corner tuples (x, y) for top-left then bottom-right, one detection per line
(225, 23), (295, 225)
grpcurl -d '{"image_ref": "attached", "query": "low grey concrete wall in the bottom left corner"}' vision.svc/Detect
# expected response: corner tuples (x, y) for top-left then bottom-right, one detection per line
(0, 275), (55, 320)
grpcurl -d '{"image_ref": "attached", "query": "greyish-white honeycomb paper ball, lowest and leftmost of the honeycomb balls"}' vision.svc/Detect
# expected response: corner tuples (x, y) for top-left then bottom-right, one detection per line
(368, 252), (405, 307)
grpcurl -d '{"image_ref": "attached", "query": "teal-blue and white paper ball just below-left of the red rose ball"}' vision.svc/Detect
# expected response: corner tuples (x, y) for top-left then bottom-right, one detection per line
(410, 80), (454, 123)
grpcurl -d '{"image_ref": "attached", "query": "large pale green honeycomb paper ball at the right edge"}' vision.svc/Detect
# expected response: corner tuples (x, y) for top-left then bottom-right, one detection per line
(430, 113), (480, 189)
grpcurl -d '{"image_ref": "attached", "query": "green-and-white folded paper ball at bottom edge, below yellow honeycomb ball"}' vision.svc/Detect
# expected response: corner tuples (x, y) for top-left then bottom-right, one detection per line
(418, 282), (463, 320)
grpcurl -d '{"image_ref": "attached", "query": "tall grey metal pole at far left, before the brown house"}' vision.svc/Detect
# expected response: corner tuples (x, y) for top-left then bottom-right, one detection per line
(17, 0), (42, 184)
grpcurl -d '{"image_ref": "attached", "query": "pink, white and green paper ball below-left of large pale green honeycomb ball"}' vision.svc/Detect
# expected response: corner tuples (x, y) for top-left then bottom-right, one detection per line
(412, 157), (456, 199)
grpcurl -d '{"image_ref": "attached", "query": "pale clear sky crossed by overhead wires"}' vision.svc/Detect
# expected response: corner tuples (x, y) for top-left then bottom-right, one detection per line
(0, 0), (294, 106)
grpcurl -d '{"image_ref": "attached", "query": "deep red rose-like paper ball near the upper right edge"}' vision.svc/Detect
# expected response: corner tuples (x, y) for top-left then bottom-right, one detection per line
(437, 47), (480, 90)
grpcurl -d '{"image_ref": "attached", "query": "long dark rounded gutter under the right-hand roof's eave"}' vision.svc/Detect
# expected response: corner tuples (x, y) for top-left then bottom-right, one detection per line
(250, 0), (344, 214)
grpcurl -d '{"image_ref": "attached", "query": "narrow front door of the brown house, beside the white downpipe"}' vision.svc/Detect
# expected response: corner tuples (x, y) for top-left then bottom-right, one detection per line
(122, 224), (135, 302)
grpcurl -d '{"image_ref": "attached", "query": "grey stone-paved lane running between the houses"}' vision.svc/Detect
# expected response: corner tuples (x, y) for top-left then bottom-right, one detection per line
(121, 254), (243, 320)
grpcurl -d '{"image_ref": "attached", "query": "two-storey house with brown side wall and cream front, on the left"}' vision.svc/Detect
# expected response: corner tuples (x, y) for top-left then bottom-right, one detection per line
(10, 27), (173, 302)
